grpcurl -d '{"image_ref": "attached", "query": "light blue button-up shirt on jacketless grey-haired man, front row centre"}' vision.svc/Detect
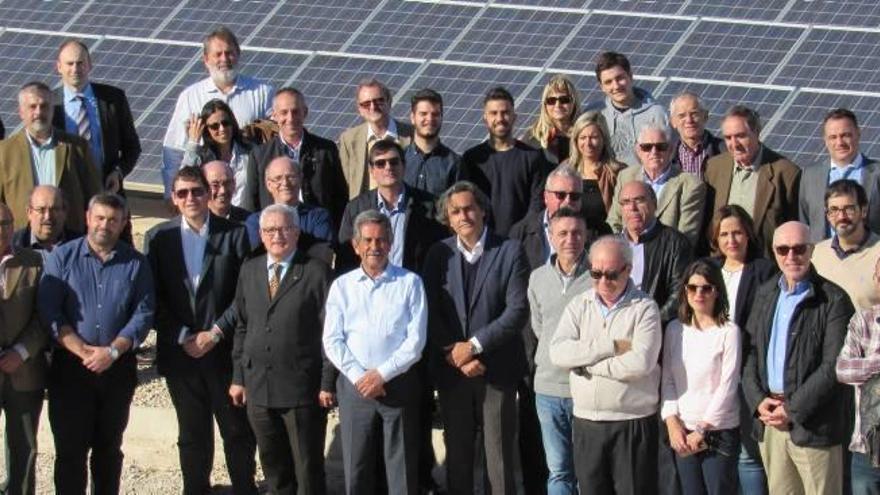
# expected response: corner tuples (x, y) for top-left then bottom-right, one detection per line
(324, 263), (428, 383)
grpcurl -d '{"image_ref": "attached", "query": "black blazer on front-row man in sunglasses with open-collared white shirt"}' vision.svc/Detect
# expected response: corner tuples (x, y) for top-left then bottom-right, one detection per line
(144, 215), (250, 375)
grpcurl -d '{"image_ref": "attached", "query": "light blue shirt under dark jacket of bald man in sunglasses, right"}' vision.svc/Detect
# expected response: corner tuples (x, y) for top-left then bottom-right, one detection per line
(767, 276), (810, 394)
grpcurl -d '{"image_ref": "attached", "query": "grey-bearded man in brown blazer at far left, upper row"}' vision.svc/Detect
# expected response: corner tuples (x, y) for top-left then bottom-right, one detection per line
(0, 82), (101, 232)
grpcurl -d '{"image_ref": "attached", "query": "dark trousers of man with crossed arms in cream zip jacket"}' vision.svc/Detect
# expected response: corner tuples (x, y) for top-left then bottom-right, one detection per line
(574, 415), (659, 495)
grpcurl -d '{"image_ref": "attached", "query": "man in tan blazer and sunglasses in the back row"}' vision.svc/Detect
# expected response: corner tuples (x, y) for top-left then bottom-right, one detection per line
(339, 79), (413, 200)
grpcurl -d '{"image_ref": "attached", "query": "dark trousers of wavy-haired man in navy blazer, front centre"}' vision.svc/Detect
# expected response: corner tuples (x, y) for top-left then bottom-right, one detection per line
(438, 377), (528, 495)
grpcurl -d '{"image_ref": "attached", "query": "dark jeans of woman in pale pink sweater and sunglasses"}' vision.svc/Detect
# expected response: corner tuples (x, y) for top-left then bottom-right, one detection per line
(675, 427), (740, 495)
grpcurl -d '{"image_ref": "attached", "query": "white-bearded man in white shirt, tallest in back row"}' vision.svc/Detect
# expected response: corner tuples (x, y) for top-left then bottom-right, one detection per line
(162, 26), (274, 198)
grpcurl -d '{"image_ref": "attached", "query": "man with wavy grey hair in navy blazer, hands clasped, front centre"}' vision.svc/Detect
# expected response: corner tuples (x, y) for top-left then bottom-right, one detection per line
(424, 182), (531, 495)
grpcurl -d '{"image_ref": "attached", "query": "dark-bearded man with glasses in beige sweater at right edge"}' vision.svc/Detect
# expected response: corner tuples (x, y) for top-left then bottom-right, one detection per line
(812, 179), (880, 311)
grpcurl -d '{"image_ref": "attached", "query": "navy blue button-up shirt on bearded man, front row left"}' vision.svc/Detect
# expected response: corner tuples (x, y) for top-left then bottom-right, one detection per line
(39, 237), (155, 347)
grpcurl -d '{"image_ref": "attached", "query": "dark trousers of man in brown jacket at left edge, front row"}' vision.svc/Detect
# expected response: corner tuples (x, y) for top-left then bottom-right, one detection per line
(0, 380), (43, 495)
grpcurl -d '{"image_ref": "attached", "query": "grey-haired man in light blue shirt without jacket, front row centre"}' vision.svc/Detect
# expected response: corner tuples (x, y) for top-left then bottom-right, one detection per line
(323, 210), (428, 494)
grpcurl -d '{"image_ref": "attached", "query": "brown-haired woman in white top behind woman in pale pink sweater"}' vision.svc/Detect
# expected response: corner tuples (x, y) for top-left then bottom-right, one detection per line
(709, 205), (777, 495)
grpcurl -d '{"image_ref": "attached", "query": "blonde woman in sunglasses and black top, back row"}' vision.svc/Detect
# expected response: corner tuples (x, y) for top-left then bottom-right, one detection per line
(523, 75), (580, 164)
